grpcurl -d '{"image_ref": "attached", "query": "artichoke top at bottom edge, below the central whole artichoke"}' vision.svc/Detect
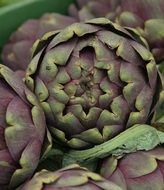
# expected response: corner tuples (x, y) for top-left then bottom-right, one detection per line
(19, 165), (122, 190)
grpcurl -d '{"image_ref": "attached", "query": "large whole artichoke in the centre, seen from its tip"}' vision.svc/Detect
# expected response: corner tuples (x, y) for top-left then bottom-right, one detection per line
(26, 18), (157, 149)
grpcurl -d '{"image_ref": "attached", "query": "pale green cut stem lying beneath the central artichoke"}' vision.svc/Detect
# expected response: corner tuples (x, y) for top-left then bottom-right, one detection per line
(63, 124), (164, 165)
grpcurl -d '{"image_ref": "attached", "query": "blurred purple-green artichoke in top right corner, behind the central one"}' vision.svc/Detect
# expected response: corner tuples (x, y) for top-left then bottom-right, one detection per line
(69, 0), (164, 62)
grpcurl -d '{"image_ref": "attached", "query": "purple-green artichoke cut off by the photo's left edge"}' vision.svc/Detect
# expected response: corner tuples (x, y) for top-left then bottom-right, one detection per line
(0, 65), (46, 190)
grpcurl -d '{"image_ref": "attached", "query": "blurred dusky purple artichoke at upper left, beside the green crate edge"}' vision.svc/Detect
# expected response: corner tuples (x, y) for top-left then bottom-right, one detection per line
(2, 13), (76, 70)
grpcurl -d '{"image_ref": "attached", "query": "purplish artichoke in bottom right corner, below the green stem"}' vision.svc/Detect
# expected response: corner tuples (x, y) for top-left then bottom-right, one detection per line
(100, 147), (164, 190)
